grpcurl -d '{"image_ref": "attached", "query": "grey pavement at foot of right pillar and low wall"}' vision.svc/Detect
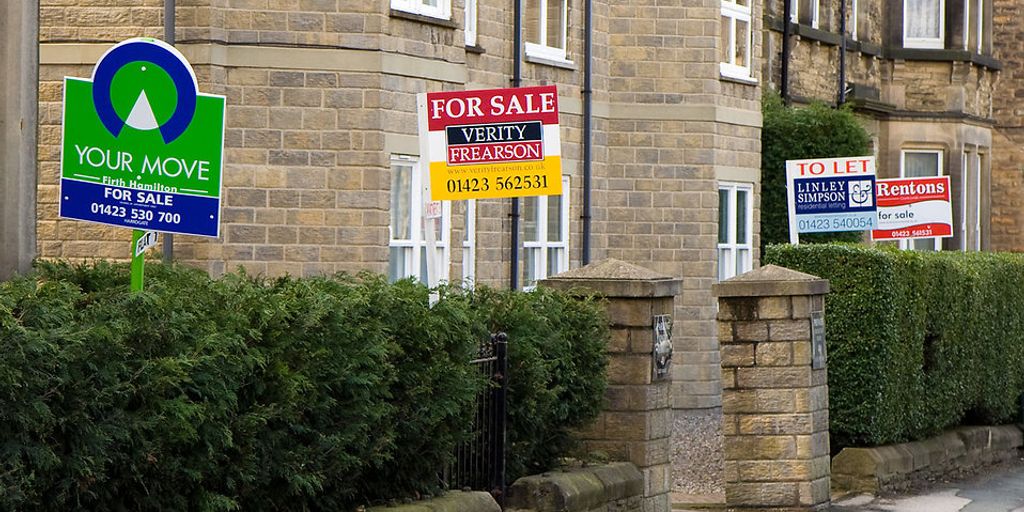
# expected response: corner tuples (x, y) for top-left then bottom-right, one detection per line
(672, 463), (1024, 512)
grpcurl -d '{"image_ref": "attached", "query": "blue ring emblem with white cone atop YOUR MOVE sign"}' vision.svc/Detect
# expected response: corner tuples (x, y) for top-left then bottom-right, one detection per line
(92, 38), (199, 143)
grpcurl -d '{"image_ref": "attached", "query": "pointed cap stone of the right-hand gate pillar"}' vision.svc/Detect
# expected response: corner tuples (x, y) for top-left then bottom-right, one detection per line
(712, 265), (828, 297)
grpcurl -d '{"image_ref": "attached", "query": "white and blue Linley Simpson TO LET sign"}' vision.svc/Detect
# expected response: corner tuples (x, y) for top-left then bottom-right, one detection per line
(785, 157), (878, 240)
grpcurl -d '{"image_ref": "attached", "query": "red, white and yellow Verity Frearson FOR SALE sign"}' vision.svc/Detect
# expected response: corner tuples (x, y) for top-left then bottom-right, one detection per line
(419, 86), (562, 201)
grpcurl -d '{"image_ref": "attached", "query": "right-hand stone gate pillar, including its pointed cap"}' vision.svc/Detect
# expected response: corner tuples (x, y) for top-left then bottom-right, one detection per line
(715, 265), (829, 511)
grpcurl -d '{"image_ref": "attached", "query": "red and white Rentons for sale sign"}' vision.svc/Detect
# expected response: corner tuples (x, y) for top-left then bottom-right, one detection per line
(871, 176), (953, 240)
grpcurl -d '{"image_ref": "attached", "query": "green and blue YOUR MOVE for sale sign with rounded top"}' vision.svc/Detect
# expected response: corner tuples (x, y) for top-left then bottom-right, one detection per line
(60, 38), (224, 237)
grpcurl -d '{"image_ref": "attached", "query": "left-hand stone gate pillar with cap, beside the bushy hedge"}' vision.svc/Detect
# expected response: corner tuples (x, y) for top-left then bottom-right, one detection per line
(541, 259), (681, 512)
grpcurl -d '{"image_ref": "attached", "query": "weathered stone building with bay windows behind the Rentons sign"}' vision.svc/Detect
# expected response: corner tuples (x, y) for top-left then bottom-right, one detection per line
(764, 0), (995, 250)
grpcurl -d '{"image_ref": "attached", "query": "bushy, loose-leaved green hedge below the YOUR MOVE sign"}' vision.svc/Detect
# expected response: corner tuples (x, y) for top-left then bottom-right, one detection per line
(0, 263), (607, 511)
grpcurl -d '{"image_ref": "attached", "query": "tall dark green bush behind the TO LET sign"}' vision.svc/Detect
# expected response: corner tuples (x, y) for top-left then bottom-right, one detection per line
(761, 91), (871, 254)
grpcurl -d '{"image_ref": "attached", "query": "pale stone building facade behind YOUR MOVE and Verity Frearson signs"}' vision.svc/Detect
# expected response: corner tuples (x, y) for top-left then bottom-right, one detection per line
(37, 0), (762, 408)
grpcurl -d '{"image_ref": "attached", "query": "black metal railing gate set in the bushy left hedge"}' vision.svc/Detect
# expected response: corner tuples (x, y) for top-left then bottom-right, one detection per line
(444, 333), (508, 506)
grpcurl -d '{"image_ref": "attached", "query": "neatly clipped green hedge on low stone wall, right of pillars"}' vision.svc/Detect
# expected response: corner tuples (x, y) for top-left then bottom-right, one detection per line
(765, 244), (1024, 450)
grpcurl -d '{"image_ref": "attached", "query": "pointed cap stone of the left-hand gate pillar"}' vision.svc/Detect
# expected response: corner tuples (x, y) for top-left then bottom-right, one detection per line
(539, 258), (682, 298)
